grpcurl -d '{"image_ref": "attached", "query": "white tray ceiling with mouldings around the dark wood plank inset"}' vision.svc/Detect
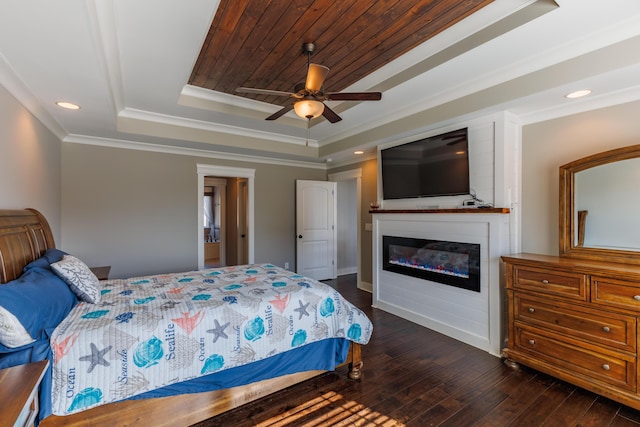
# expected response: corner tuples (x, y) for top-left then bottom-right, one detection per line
(0, 0), (640, 165)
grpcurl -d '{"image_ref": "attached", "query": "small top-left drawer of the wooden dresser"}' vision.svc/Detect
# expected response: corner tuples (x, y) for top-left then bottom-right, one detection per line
(513, 267), (588, 301)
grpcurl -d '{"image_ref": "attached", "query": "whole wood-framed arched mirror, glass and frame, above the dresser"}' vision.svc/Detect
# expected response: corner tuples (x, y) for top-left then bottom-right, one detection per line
(559, 145), (640, 264)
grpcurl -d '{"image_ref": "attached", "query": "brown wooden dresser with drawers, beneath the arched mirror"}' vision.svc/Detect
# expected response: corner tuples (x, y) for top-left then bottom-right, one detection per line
(502, 253), (640, 409)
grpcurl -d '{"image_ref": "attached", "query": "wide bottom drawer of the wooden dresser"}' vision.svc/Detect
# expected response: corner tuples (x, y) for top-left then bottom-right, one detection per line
(515, 322), (636, 391)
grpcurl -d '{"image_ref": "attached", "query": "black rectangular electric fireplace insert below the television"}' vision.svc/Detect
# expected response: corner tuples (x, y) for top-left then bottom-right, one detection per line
(382, 236), (480, 292)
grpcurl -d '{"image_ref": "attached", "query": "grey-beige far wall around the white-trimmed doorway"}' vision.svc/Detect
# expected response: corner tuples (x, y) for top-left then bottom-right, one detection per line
(61, 144), (326, 278)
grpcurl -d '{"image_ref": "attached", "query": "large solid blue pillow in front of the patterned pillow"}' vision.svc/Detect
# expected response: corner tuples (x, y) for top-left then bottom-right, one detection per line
(0, 260), (78, 345)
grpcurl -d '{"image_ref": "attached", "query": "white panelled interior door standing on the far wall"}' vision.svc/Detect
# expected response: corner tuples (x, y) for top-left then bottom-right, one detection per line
(296, 180), (337, 280)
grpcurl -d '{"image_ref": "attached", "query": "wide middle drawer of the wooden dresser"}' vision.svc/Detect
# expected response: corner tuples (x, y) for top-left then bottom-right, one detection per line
(514, 292), (636, 352)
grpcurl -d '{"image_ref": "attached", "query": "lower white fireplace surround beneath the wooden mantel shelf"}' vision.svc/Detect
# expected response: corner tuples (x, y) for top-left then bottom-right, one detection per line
(373, 213), (509, 356)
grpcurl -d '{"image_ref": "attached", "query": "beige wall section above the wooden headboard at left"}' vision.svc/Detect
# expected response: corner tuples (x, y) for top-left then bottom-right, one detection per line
(0, 85), (61, 242)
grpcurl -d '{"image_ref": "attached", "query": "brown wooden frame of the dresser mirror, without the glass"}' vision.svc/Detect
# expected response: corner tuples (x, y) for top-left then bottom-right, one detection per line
(558, 145), (640, 264)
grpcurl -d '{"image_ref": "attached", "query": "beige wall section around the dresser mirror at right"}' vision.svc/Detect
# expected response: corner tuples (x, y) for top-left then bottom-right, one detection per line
(521, 102), (640, 255)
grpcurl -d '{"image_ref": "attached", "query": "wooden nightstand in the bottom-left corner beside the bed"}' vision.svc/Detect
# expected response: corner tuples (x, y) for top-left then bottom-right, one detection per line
(0, 360), (49, 427)
